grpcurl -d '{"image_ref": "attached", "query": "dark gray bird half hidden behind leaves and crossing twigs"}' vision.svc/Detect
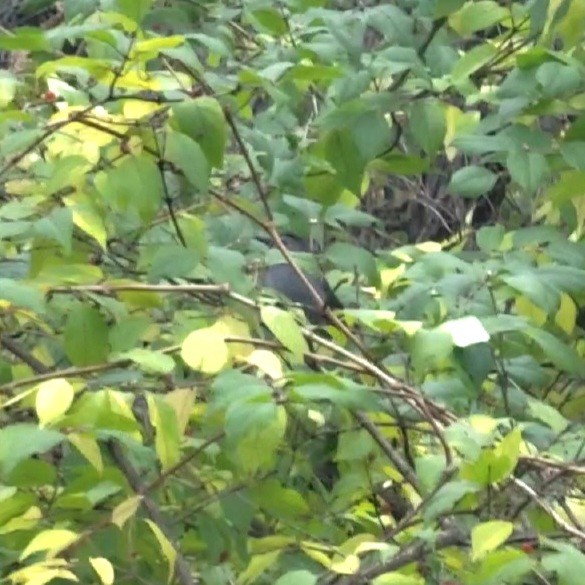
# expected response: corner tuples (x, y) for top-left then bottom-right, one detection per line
(256, 235), (343, 324)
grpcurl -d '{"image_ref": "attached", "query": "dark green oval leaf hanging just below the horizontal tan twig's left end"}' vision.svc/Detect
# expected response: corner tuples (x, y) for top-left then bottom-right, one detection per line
(63, 305), (109, 366)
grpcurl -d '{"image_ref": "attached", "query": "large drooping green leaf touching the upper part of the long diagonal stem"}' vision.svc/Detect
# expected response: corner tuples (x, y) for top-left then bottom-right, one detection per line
(172, 96), (227, 168)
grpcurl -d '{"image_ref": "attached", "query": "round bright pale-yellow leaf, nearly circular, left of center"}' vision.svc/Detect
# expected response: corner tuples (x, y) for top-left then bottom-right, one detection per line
(181, 327), (229, 374)
